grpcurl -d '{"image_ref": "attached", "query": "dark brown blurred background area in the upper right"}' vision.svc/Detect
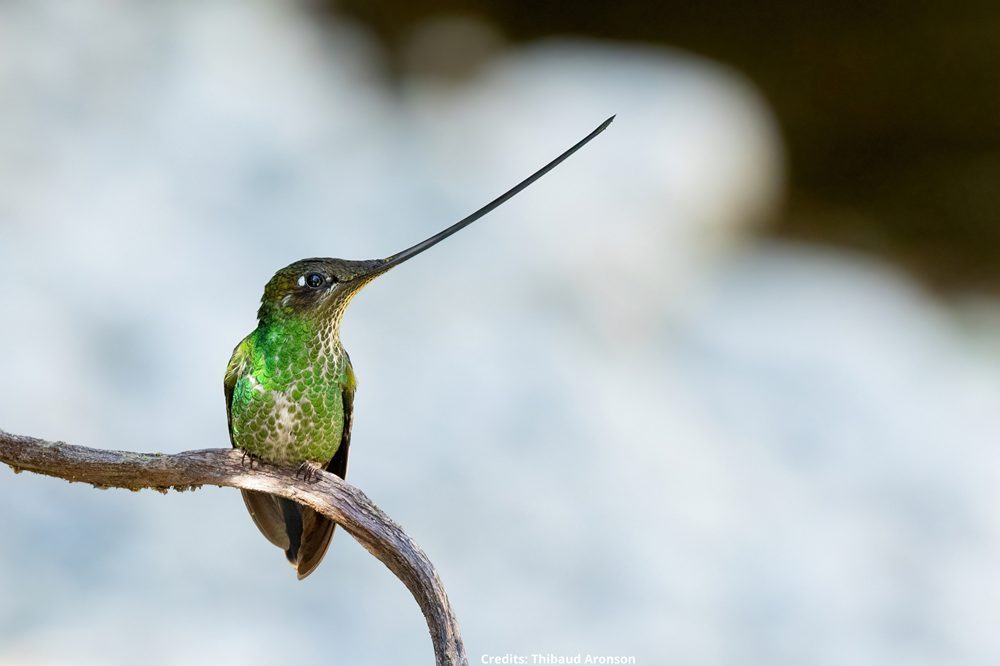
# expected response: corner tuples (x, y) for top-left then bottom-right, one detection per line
(329, 0), (1000, 291)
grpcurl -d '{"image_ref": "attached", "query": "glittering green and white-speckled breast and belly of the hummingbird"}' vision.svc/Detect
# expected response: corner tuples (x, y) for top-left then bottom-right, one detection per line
(225, 321), (354, 466)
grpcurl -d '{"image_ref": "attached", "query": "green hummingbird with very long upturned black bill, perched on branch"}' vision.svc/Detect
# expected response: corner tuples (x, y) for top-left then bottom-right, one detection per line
(224, 116), (615, 580)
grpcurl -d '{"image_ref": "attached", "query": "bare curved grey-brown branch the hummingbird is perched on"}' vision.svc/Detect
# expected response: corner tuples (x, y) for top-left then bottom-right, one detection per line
(0, 430), (468, 666)
